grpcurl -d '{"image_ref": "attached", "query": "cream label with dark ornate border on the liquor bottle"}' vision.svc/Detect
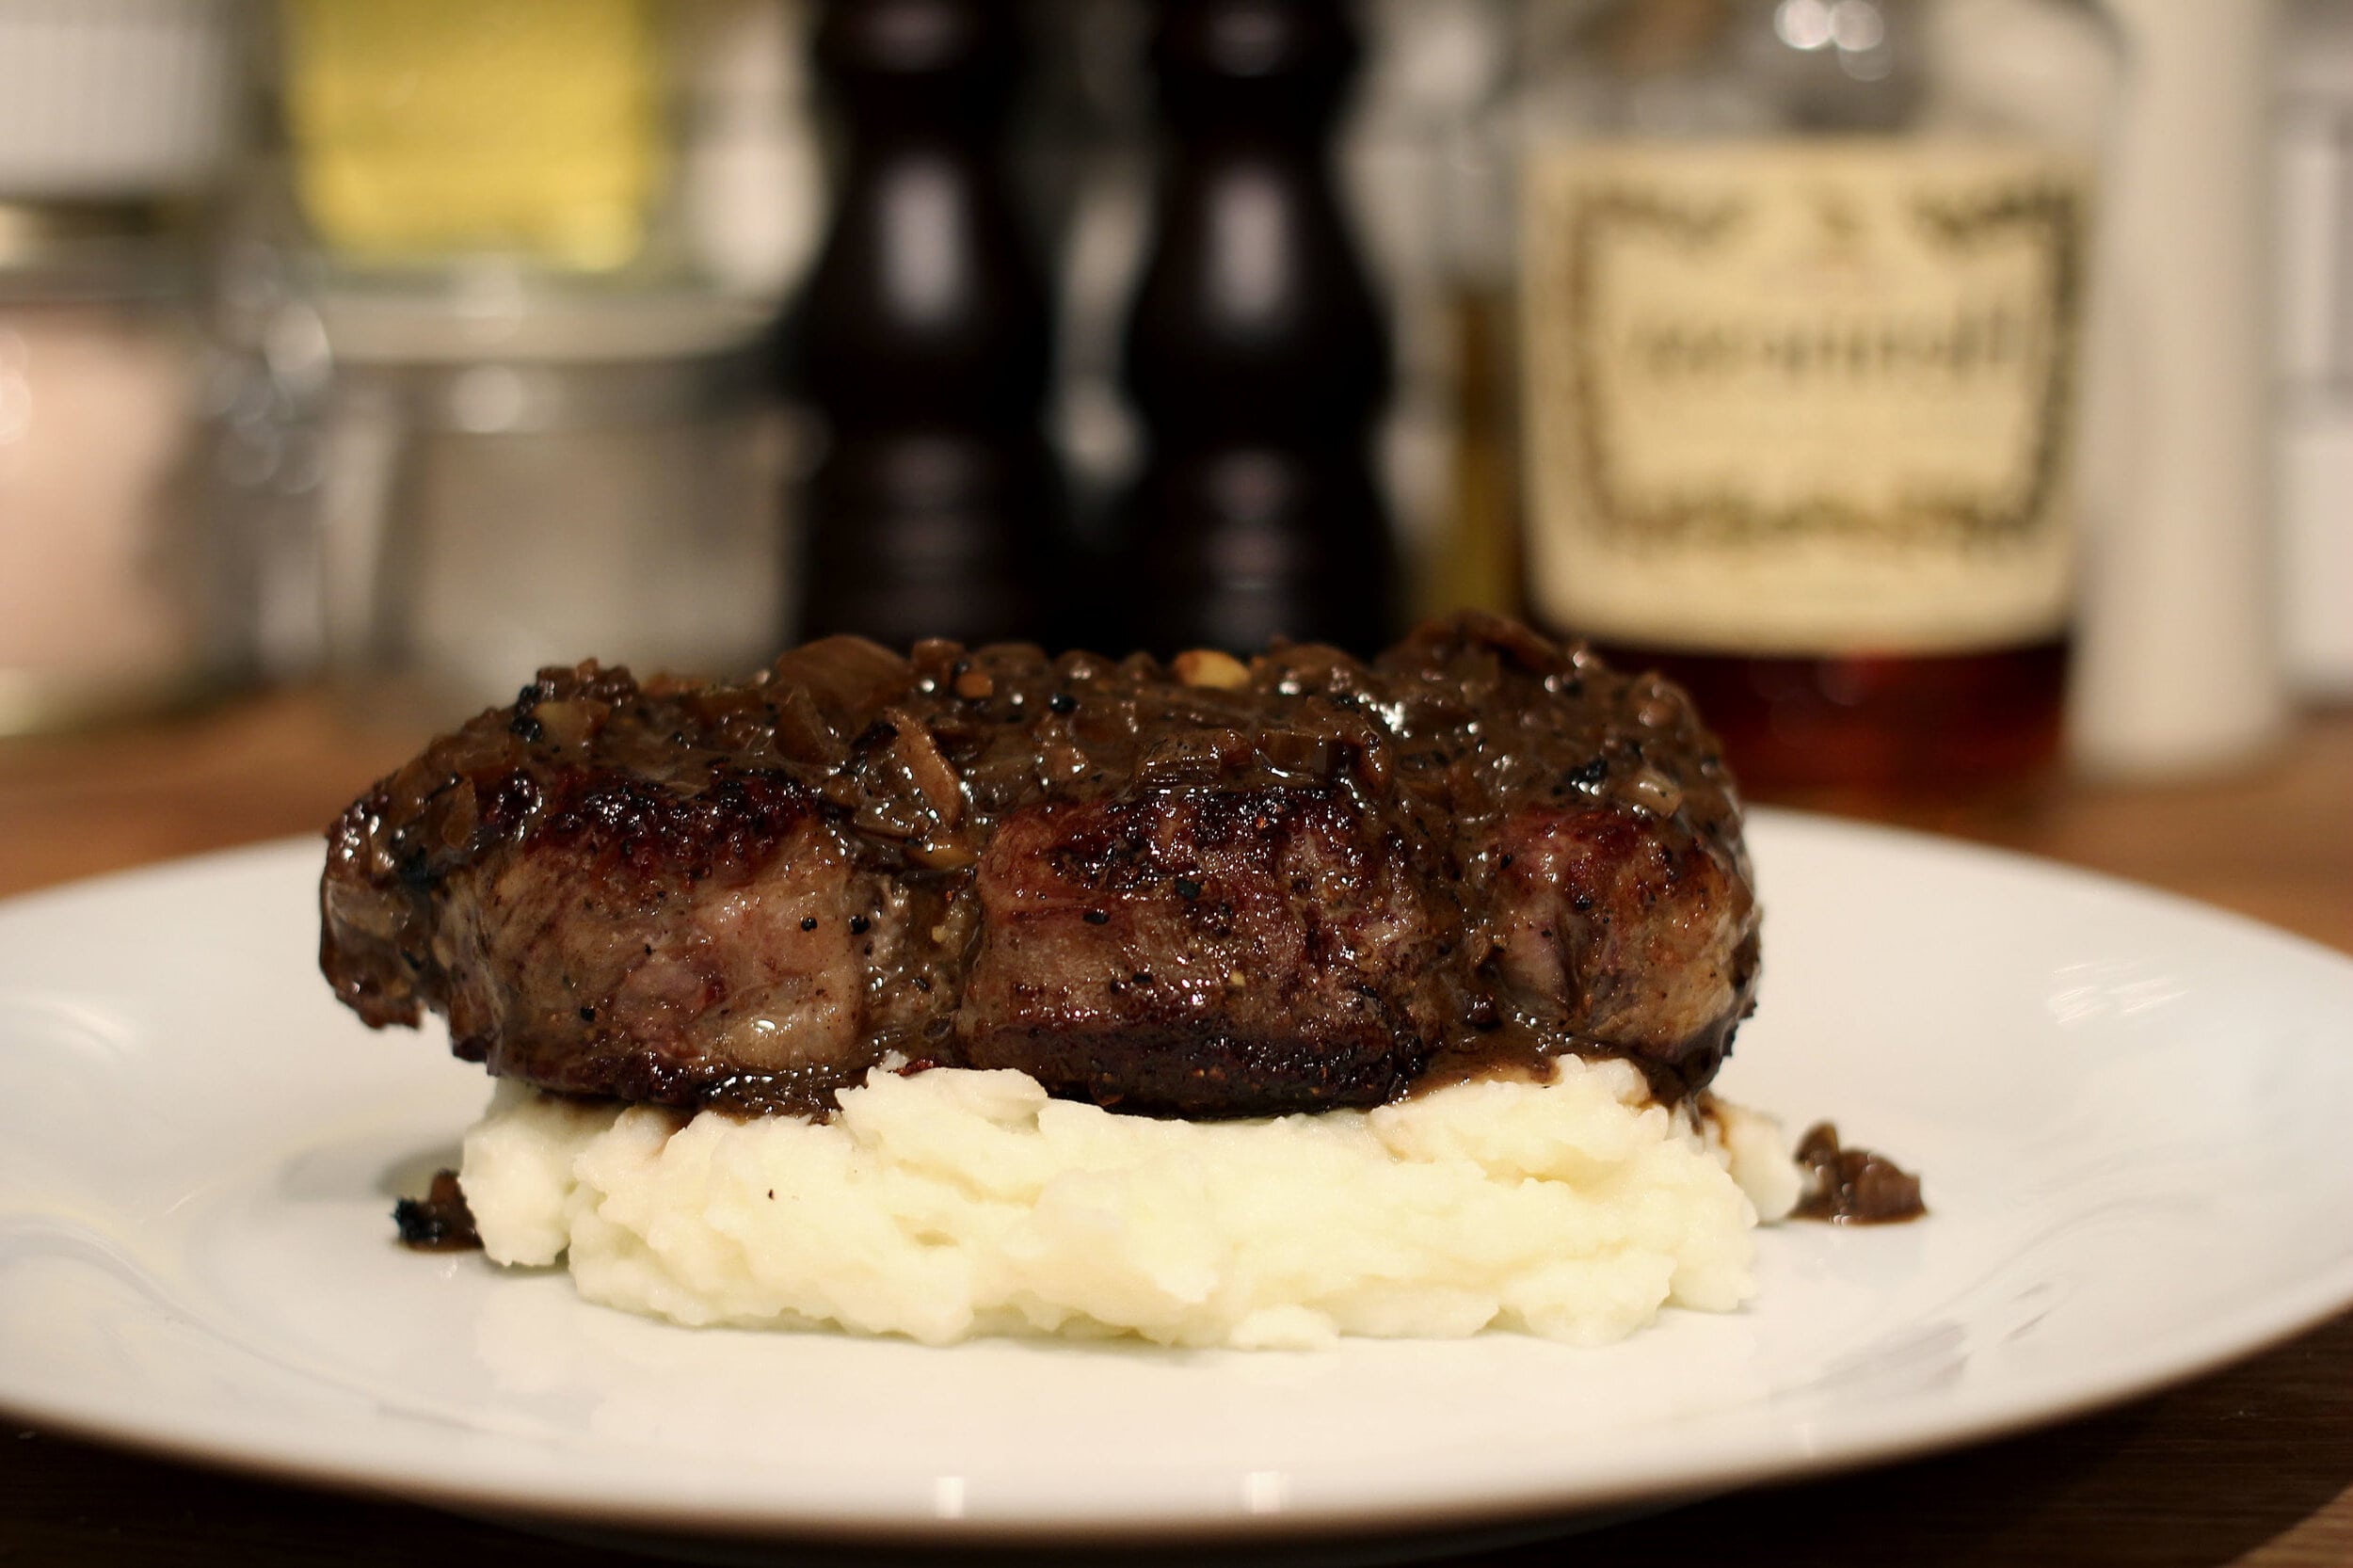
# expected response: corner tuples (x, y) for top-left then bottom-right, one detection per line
(1523, 139), (2088, 654)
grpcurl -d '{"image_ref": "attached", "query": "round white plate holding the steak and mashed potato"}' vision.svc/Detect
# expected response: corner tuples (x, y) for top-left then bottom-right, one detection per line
(0, 812), (2353, 1544)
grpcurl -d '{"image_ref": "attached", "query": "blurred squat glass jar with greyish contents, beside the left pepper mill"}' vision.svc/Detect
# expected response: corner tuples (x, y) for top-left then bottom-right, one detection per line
(318, 280), (791, 704)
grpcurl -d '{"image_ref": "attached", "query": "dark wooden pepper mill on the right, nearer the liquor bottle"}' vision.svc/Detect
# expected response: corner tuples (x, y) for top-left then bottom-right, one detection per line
(1115, 0), (1398, 652)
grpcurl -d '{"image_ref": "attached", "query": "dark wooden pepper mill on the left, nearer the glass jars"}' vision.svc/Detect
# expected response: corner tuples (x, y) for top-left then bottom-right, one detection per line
(789, 0), (1062, 648)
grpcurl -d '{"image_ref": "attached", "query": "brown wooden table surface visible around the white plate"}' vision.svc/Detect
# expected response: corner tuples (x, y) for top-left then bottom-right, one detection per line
(0, 695), (2353, 1568)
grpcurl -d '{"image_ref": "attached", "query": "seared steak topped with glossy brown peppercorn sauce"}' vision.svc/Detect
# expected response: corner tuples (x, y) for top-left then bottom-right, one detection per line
(320, 616), (1758, 1116)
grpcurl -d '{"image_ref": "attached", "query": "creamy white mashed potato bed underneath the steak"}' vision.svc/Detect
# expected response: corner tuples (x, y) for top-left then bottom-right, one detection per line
(461, 1060), (1798, 1347)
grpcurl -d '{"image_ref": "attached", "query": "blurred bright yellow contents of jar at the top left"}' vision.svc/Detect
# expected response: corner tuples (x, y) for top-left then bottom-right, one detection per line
(285, 0), (666, 271)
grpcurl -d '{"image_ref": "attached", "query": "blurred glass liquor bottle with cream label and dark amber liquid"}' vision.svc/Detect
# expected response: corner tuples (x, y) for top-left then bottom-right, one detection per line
(1520, 0), (2116, 793)
